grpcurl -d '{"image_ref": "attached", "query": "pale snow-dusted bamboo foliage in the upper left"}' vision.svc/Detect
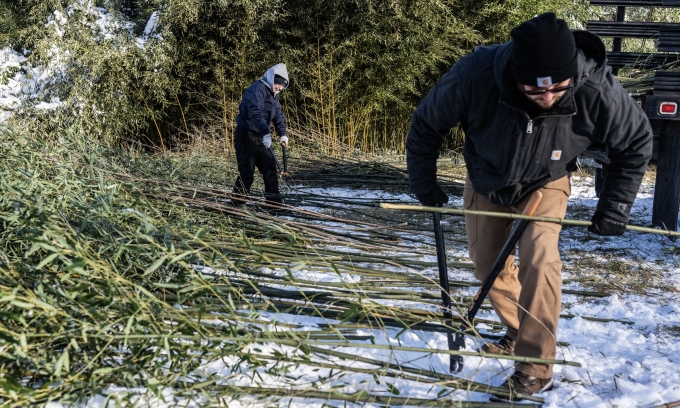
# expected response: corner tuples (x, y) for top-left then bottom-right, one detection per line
(4, 0), (179, 149)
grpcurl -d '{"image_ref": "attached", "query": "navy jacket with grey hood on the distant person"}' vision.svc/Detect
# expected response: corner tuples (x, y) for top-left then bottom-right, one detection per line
(236, 64), (288, 137)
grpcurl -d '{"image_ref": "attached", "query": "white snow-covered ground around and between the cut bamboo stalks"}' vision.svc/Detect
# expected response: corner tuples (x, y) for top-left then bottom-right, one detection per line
(210, 181), (680, 408)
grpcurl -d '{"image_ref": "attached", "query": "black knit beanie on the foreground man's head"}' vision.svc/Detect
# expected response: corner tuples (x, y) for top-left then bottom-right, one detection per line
(510, 12), (577, 86)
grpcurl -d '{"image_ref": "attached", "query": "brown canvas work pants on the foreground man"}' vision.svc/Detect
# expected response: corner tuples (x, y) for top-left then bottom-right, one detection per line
(463, 176), (571, 378)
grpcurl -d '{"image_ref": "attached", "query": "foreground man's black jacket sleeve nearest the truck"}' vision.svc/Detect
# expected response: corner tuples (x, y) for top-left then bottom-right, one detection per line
(597, 77), (652, 222)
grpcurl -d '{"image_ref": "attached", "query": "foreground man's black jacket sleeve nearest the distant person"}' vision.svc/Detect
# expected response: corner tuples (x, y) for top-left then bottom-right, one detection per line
(406, 65), (465, 194)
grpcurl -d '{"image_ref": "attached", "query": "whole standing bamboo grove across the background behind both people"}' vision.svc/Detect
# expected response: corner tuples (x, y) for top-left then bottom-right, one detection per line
(0, 0), (652, 154)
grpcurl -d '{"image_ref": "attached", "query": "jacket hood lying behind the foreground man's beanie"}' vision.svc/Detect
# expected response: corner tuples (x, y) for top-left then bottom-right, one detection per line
(494, 30), (607, 92)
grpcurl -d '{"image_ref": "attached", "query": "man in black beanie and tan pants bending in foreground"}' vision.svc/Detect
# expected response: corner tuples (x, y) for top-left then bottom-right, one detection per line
(406, 13), (652, 401)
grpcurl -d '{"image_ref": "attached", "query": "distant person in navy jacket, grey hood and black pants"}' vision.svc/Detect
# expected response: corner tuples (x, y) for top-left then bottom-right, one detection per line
(232, 64), (288, 210)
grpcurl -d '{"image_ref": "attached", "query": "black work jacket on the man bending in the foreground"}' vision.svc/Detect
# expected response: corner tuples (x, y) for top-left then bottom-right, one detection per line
(406, 31), (652, 222)
